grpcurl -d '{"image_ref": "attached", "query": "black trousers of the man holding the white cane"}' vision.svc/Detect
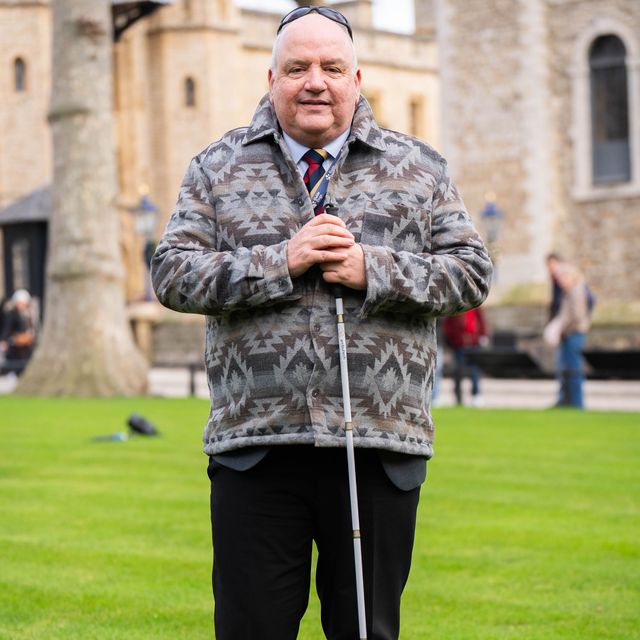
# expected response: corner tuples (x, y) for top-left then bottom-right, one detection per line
(209, 446), (420, 640)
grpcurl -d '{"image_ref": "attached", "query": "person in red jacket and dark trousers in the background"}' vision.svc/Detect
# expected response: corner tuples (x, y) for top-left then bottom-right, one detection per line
(443, 307), (489, 407)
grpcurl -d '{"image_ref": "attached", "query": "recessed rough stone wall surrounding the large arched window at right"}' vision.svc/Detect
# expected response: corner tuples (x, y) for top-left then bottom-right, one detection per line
(548, 0), (640, 304)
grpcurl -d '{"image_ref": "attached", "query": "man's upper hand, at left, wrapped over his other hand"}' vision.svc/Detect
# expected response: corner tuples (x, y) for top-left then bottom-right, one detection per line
(287, 213), (356, 282)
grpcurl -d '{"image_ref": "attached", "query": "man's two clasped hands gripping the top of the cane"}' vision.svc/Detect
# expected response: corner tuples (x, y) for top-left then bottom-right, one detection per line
(287, 213), (367, 290)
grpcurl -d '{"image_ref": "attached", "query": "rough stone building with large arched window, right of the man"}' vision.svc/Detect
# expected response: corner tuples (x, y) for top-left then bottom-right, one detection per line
(437, 0), (640, 330)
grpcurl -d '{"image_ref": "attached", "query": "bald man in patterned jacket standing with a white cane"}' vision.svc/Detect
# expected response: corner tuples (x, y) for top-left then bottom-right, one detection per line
(152, 7), (491, 640)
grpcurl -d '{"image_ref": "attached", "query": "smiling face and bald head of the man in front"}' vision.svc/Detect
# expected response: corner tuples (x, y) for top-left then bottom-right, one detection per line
(269, 13), (360, 148)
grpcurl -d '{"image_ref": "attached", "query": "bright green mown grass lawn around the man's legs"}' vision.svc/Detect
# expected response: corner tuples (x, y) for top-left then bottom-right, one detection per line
(0, 396), (640, 640)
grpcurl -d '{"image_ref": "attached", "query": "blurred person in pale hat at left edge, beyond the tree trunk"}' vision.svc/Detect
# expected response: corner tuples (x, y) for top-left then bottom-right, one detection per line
(0, 289), (36, 375)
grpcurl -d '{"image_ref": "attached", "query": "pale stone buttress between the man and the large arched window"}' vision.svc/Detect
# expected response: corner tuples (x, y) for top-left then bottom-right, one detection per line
(438, 0), (535, 282)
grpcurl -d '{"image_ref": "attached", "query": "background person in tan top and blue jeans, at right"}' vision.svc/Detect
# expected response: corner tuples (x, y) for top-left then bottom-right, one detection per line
(544, 262), (591, 409)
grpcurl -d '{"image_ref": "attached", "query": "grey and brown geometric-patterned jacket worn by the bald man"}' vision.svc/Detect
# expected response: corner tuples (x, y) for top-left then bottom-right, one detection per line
(152, 96), (492, 457)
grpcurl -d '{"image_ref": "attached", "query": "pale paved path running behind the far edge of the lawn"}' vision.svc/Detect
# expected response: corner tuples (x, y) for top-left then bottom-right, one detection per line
(0, 368), (640, 412)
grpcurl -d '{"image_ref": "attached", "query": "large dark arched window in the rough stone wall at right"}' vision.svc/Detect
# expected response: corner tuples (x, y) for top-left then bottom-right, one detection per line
(589, 35), (631, 184)
